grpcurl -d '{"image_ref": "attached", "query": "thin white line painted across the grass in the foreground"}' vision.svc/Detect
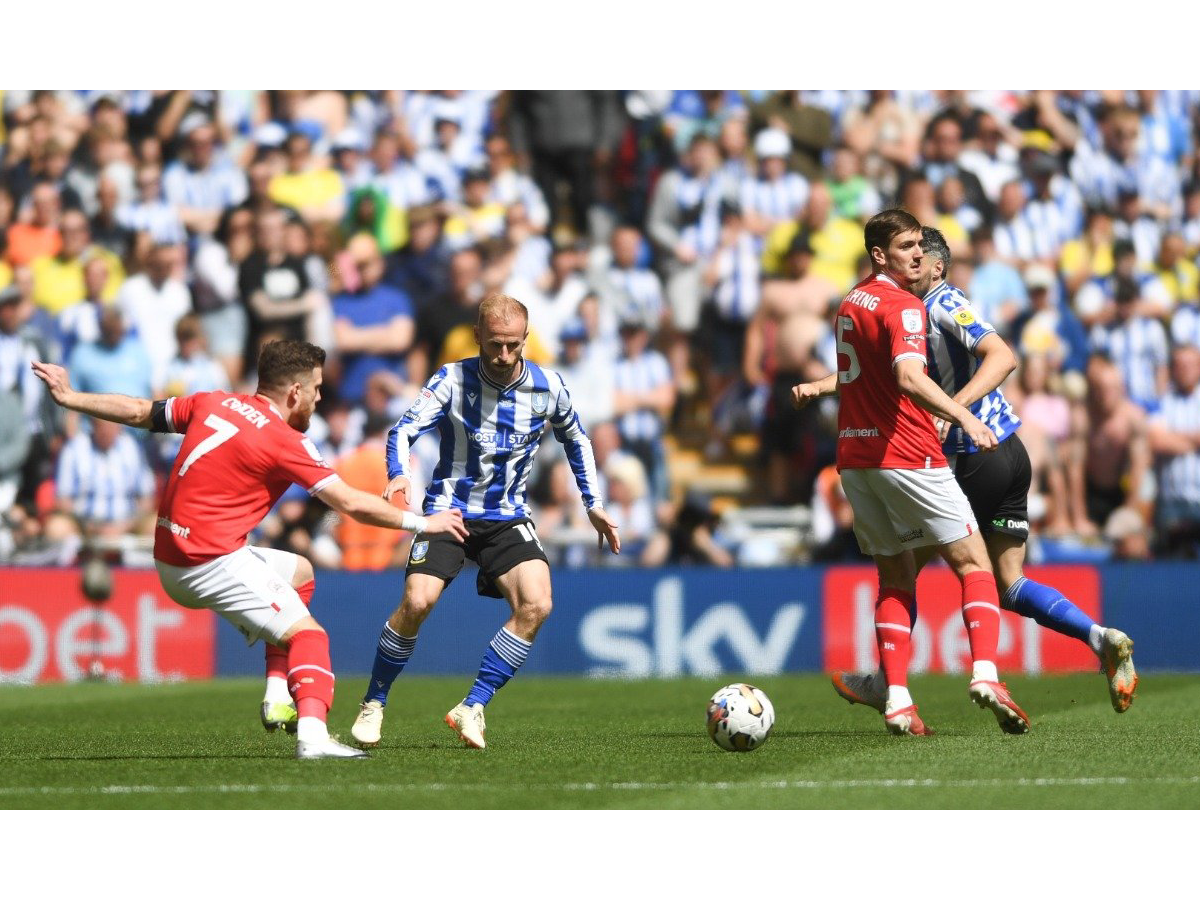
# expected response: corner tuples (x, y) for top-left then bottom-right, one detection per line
(0, 775), (1200, 797)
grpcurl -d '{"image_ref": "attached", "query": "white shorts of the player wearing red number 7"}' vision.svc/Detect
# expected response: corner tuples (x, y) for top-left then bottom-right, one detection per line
(155, 544), (308, 644)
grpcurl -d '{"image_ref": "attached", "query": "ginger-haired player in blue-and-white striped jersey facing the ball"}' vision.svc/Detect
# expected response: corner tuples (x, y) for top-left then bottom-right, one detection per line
(352, 294), (620, 750)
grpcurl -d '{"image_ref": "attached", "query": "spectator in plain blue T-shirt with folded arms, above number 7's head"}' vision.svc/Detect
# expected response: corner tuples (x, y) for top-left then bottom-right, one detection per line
(334, 234), (414, 403)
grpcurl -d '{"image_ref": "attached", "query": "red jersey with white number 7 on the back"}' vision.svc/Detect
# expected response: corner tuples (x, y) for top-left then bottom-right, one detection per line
(154, 391), (337, 566)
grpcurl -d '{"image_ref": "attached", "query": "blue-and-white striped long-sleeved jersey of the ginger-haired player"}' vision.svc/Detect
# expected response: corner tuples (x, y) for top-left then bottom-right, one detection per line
(386, 356), (601, 520)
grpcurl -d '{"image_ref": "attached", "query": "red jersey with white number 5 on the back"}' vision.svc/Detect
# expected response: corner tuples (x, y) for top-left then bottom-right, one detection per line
(834, 274), (946, 470)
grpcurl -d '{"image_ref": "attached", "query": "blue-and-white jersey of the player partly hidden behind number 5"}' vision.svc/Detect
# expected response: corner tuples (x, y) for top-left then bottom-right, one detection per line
(925, 281), (1021, 456)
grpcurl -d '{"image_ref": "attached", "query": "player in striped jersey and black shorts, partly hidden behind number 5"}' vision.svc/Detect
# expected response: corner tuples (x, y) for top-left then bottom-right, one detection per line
(834, 227), (1138, 713)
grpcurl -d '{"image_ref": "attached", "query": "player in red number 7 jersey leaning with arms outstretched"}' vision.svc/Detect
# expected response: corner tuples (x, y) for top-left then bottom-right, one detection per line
(32, 341), (467, 760)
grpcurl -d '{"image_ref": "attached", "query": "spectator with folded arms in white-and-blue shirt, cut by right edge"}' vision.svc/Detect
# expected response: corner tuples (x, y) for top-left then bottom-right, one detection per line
(1150, 347), (1200, 559)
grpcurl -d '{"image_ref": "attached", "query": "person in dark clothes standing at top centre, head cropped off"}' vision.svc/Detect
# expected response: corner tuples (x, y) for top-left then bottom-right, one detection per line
(509, 90), (623, 235)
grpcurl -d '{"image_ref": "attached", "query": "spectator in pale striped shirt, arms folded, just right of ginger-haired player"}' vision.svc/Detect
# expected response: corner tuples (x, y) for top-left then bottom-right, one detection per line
(613, 310), (676, 499)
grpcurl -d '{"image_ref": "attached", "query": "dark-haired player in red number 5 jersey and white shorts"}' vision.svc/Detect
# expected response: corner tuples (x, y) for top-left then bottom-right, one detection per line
(792, 210), (1028, 734)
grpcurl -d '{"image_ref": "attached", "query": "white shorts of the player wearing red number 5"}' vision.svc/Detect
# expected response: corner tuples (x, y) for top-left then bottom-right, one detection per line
(841, 466), (979, 557)
